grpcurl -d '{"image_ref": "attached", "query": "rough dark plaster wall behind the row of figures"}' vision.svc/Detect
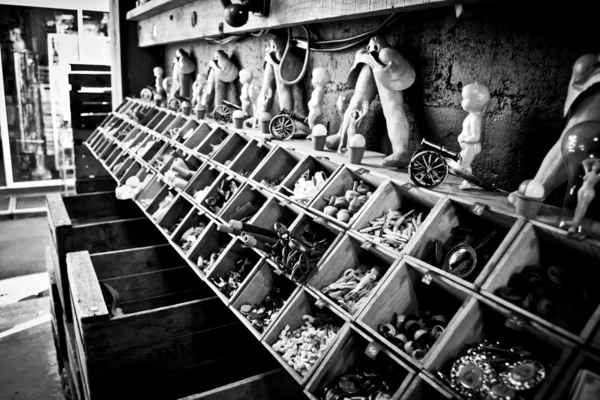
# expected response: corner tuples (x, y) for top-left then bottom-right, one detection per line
(166, 2), (600, 194)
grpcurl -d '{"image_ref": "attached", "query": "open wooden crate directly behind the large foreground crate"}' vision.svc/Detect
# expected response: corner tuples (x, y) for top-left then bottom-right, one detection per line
(46, 192), (165, 320)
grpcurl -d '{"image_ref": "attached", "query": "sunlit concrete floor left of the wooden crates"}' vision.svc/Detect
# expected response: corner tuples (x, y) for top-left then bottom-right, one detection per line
(0, 217), (63, 400)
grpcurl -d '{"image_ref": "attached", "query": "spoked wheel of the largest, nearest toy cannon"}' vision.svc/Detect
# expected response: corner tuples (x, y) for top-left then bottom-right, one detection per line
(408, 150), (448, 188)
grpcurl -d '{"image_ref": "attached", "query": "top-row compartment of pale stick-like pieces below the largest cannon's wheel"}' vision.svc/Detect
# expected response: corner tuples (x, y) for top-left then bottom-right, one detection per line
(351, 181), (442, 253)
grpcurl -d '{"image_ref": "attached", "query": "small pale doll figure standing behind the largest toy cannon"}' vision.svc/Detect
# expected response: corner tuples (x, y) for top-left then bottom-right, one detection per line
(458, 82), (490, 189)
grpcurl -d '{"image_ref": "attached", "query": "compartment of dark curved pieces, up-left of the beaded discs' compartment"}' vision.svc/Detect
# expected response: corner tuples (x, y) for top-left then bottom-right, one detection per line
(357, 257), (470, 365)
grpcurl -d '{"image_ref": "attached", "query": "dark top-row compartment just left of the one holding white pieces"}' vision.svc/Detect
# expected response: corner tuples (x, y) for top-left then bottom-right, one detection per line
(250, 146), (302, 192)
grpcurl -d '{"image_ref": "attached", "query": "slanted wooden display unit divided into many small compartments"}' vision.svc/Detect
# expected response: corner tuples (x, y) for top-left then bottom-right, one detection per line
(81, 99), (600, 400)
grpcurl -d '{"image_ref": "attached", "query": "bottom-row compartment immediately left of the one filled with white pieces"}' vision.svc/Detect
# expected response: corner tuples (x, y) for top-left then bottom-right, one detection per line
(231, 259), (300, 340)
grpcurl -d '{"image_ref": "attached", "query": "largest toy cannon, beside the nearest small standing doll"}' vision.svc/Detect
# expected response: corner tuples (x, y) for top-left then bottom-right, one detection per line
(408, 139), (500, 191)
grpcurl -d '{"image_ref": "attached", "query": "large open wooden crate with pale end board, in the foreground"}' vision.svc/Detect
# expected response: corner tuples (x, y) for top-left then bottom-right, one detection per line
(67, 252), (274, 399)
